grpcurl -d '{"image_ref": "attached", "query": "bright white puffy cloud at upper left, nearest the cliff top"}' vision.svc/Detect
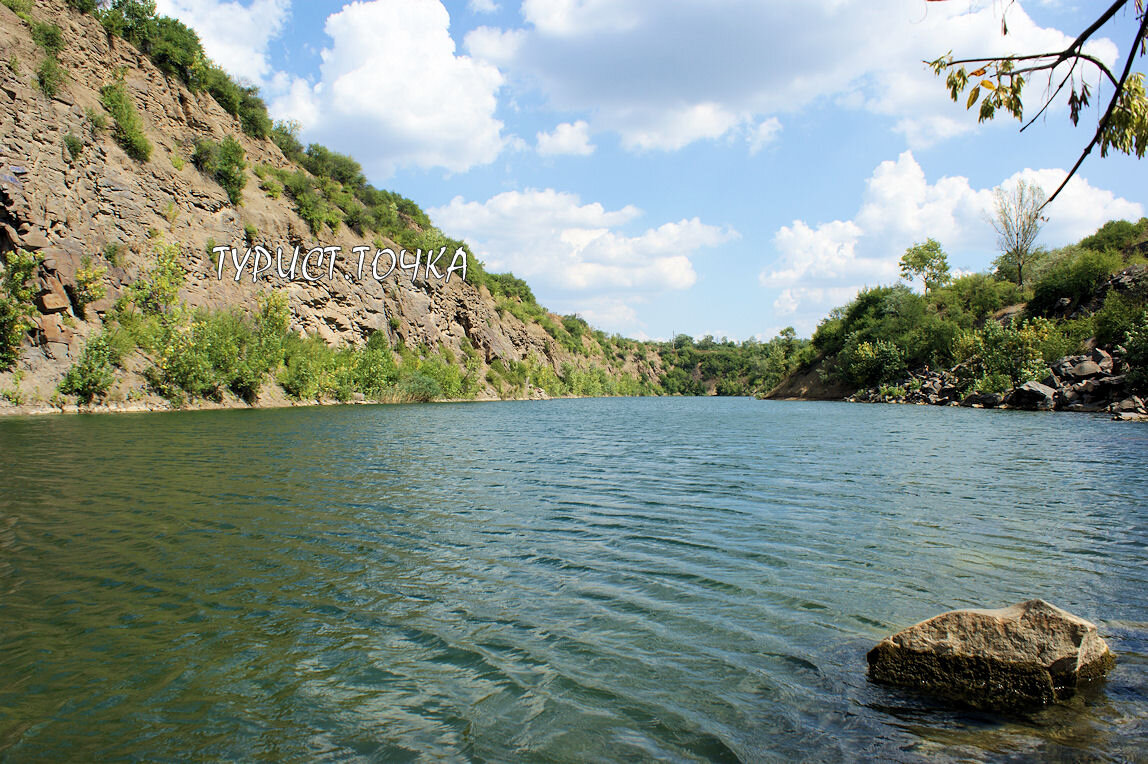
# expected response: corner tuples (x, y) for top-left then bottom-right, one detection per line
(271, 0), (506, 178)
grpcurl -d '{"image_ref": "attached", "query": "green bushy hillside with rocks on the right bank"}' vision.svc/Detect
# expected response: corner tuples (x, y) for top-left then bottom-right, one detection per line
(768, 218), (1148, 411)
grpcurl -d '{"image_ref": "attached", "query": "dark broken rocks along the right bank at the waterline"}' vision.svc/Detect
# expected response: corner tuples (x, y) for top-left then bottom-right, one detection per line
(846, 348), (1148, 421)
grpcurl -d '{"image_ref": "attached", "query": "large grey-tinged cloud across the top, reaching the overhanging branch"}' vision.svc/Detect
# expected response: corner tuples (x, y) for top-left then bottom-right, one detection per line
(465, 0), (1116, 153)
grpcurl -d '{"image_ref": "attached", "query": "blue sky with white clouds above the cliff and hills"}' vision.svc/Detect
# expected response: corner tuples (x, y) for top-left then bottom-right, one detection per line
(157, 0), (1148, 340)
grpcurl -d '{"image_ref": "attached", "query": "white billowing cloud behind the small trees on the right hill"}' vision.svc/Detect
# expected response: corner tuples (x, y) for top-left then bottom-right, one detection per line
(759, 151), (1143, 334)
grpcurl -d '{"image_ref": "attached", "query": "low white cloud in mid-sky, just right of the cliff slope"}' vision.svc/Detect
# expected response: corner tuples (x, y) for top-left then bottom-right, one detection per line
(429, 188), (738, 292)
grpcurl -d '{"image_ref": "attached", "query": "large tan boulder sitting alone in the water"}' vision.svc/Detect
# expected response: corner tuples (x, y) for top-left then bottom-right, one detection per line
(868, 600), (1116, 710)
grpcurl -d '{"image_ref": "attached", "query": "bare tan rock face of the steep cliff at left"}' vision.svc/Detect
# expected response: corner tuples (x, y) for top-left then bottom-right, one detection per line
(0, 0), (660, 408)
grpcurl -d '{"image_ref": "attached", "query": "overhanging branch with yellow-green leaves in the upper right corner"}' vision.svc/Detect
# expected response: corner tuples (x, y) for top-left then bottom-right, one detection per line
(925, 0), (1148, 205)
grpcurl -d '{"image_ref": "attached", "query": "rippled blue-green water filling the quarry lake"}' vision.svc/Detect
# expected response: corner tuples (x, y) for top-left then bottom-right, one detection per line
(0, 398), (1148, 762)
